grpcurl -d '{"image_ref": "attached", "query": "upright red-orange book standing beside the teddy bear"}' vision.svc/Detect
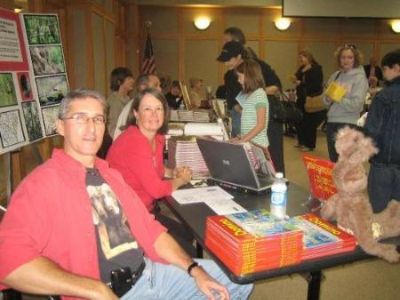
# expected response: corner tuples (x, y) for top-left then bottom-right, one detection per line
(303, 154), (337, 200)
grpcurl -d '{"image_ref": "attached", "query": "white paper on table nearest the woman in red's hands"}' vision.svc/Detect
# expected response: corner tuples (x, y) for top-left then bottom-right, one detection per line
(172, 186), (233, 204)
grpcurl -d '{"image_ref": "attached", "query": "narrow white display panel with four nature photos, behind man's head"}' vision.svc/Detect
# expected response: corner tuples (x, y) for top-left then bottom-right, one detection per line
(20, 14), (69, 137)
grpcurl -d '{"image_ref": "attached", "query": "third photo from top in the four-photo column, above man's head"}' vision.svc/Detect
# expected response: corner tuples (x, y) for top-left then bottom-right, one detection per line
(36, 75), (68, 106)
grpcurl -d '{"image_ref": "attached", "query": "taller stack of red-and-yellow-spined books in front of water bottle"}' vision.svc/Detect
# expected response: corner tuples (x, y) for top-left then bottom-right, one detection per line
(205, 209), (303, 276)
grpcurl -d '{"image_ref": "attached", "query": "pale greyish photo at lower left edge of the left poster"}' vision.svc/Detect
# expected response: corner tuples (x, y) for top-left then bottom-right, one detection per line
(0, 110), (25, 148)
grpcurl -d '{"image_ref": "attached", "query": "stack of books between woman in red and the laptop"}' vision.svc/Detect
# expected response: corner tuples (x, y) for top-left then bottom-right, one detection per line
(168, 136), (209, 179)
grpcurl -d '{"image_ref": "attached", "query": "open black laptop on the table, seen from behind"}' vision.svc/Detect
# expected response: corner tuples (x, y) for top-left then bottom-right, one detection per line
(197, 138), (274, 192)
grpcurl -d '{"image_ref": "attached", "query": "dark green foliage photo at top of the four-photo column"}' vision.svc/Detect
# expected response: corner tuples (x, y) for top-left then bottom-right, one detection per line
(24, 15), (61, 45)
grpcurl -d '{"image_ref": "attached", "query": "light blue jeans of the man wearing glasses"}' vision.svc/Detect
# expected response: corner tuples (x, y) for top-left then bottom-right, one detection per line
(121, 259), (253, 300)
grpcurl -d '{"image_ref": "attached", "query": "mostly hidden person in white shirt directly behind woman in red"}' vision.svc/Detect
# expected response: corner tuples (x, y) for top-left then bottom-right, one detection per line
(112, 74), (161, 140)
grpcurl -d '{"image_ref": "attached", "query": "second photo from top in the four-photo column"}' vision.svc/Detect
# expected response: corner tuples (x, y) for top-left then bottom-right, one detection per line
(29, 46), (65, 76)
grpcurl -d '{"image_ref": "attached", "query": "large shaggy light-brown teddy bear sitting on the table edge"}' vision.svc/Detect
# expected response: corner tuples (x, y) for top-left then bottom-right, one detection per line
(321, 127), (400, 262)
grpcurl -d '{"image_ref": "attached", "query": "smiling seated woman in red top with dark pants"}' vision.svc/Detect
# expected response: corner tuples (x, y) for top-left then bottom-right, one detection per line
(107, 89), (195, 255)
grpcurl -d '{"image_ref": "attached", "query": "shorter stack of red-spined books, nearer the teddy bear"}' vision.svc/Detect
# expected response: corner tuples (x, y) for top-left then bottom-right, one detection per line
(289, 213), (357, 260)
